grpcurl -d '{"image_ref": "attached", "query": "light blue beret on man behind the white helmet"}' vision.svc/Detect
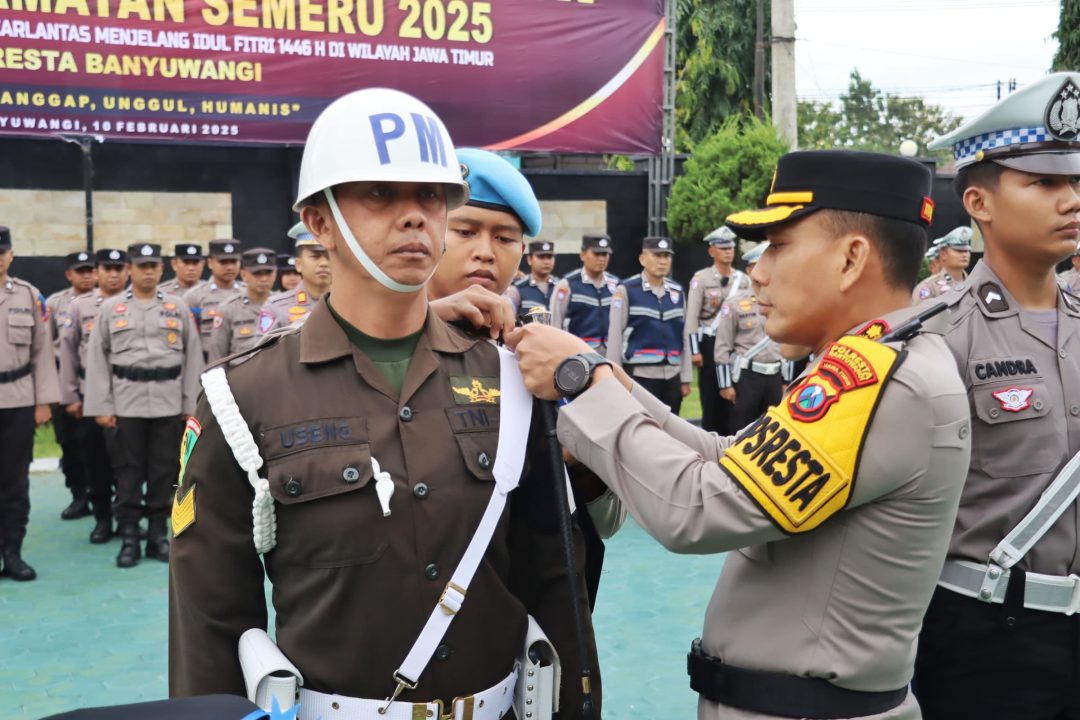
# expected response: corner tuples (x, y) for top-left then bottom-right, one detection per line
(458, 148), (541, 237)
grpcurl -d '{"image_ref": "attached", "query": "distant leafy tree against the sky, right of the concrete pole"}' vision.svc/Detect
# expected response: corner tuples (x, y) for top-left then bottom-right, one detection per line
(798, 70), (960, 160)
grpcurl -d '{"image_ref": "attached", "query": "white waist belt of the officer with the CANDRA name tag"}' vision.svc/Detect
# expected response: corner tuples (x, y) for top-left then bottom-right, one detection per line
(937, 560), (1080, 615)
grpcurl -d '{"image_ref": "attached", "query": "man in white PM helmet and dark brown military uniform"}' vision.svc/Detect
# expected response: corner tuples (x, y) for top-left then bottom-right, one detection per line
(170, 89), (599, 720)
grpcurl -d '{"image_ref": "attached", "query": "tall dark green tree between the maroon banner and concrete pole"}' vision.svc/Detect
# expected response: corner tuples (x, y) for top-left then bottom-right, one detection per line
(675, 0), (769, 152)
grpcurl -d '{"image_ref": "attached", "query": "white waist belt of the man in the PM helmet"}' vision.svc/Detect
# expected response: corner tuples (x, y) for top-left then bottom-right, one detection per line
(297, 665), (517, 720)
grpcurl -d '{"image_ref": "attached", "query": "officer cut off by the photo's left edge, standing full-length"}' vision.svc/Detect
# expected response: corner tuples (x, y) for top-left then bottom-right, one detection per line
(0, 227), (59, 581)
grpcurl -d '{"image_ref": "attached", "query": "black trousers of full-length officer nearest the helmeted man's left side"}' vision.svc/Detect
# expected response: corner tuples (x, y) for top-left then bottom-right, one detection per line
(106, 415), (184, 526)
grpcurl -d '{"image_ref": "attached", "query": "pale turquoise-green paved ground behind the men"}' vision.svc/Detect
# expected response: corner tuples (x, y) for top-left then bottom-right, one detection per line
(6, 473), (723, 720)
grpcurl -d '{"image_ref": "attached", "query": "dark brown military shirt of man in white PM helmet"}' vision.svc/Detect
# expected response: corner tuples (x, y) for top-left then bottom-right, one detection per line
(168, 302), (598, 718)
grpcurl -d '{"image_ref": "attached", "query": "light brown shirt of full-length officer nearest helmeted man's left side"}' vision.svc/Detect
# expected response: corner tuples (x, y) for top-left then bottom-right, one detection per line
(83, 290), (203, 418)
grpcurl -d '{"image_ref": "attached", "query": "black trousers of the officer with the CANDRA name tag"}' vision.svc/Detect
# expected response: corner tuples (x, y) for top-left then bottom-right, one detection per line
(913, 582), (1080, 720)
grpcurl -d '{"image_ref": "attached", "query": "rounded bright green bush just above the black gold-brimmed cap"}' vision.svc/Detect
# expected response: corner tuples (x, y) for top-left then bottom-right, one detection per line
(667, 116), (787, 243)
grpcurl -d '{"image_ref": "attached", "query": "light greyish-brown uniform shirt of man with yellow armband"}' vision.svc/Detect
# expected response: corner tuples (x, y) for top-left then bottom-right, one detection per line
(558, 310), (970, 720)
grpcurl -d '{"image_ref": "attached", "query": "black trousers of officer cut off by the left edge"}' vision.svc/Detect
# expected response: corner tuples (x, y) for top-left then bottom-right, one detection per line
(0, 408), (33, 551)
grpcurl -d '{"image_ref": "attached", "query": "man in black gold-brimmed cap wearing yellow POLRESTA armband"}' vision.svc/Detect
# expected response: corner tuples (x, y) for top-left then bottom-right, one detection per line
(508, 151), (970, 720)
